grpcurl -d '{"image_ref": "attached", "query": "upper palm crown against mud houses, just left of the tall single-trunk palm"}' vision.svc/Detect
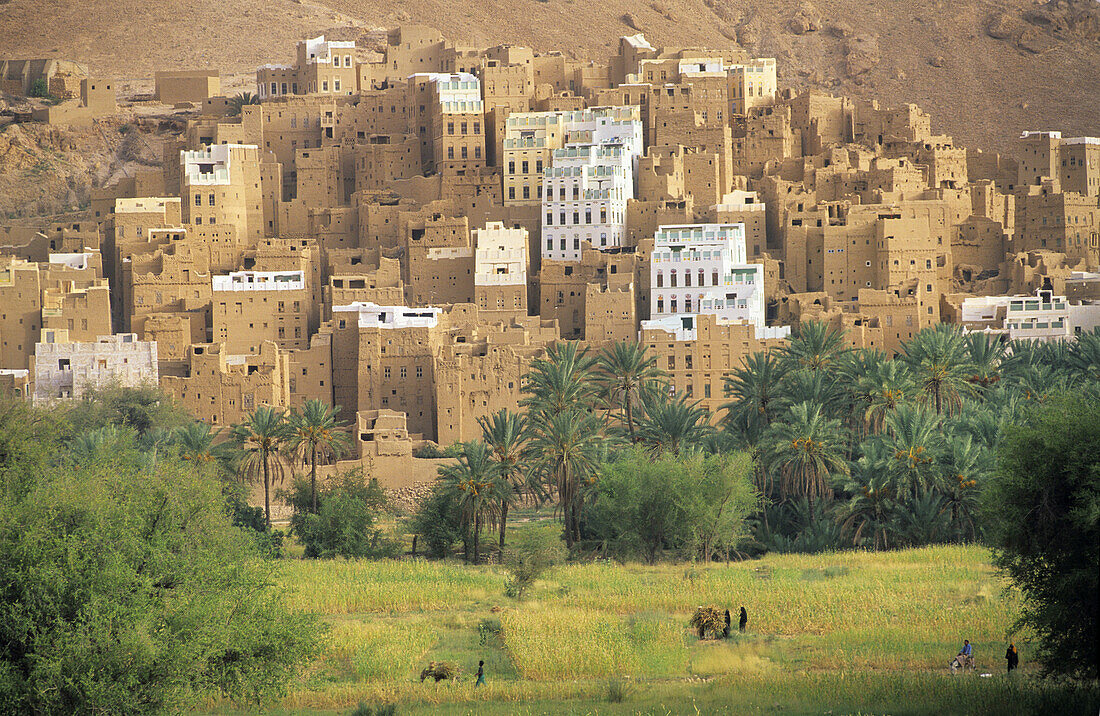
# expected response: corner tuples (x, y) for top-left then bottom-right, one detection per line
(519, 341), (596, 416)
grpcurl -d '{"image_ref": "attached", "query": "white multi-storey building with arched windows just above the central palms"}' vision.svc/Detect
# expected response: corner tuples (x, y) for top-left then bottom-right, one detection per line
(649, 223), (765, 330)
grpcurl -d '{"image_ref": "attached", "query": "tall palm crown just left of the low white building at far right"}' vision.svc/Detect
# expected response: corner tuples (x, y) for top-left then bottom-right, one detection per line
(902, 323), (975, 414)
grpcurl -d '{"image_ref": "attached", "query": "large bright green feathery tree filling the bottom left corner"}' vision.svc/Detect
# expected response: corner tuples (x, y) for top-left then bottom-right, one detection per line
(0, 449), (326, 713)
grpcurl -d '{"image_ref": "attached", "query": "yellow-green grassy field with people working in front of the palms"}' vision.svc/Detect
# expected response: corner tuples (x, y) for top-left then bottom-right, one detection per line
(210, 547), (1098, 714)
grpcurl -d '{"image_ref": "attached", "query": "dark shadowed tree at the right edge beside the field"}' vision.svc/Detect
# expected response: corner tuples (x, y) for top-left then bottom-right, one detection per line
(986, 398), (1100, 679)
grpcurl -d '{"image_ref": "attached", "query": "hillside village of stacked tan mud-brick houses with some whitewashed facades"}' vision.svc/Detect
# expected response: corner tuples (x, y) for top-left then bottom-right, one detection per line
(0, 25), (1100, 486)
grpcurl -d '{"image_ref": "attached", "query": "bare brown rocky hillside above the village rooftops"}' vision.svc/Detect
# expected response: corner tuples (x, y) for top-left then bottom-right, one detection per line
(0, 0), (1100, 151)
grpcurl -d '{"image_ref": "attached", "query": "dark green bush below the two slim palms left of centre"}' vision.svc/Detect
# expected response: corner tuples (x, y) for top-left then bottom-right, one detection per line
(289, 471), (399, 559)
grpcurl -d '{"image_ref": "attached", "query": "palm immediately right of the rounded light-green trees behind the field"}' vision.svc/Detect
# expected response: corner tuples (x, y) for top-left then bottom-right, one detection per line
(768, 403), (848, 505)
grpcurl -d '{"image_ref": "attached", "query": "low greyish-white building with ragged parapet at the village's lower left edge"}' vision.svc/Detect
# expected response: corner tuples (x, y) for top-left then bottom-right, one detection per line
(34, 330), (160, 404)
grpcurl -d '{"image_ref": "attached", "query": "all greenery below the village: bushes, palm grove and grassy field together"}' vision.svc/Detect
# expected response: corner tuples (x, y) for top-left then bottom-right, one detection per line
(0, 323), (1100, 714)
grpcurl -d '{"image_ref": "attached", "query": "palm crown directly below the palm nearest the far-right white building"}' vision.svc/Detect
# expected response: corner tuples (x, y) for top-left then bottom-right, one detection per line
(881, 406), (944, 496)
